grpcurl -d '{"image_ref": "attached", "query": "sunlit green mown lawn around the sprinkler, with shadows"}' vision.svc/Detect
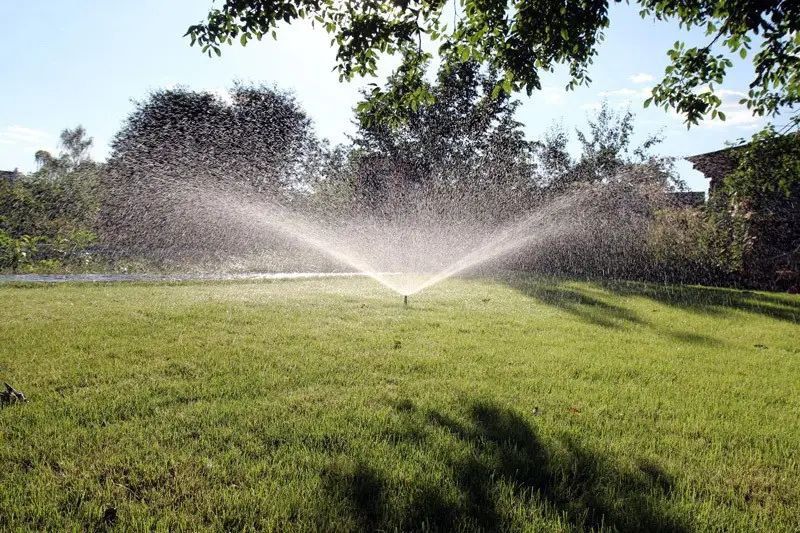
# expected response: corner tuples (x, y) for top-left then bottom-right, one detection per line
(0, 279), (800, 531)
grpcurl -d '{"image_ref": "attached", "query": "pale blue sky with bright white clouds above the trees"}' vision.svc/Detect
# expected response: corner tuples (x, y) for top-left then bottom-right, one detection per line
(0, 0), (776, 190)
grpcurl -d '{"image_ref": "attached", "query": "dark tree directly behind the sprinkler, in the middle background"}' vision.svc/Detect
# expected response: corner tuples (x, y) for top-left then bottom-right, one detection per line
(344, 62), (536, 215)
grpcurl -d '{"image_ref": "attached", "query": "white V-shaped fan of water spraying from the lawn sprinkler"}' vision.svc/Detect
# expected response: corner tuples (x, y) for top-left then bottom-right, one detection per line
(109, 159), (584, 300)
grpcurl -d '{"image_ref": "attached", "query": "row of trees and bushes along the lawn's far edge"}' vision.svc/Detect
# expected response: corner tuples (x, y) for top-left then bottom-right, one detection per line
(0, 74), (800, 289)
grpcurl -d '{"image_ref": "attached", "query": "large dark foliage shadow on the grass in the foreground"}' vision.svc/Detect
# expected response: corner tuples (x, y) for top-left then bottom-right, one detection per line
(323, 401), (688, 531)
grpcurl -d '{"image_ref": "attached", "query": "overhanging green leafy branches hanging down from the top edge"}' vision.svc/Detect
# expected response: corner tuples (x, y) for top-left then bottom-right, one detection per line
(186, 0), (800, 125)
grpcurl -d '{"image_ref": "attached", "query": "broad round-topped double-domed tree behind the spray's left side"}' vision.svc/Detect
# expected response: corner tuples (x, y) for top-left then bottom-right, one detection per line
(102, 85), (317, 262)
